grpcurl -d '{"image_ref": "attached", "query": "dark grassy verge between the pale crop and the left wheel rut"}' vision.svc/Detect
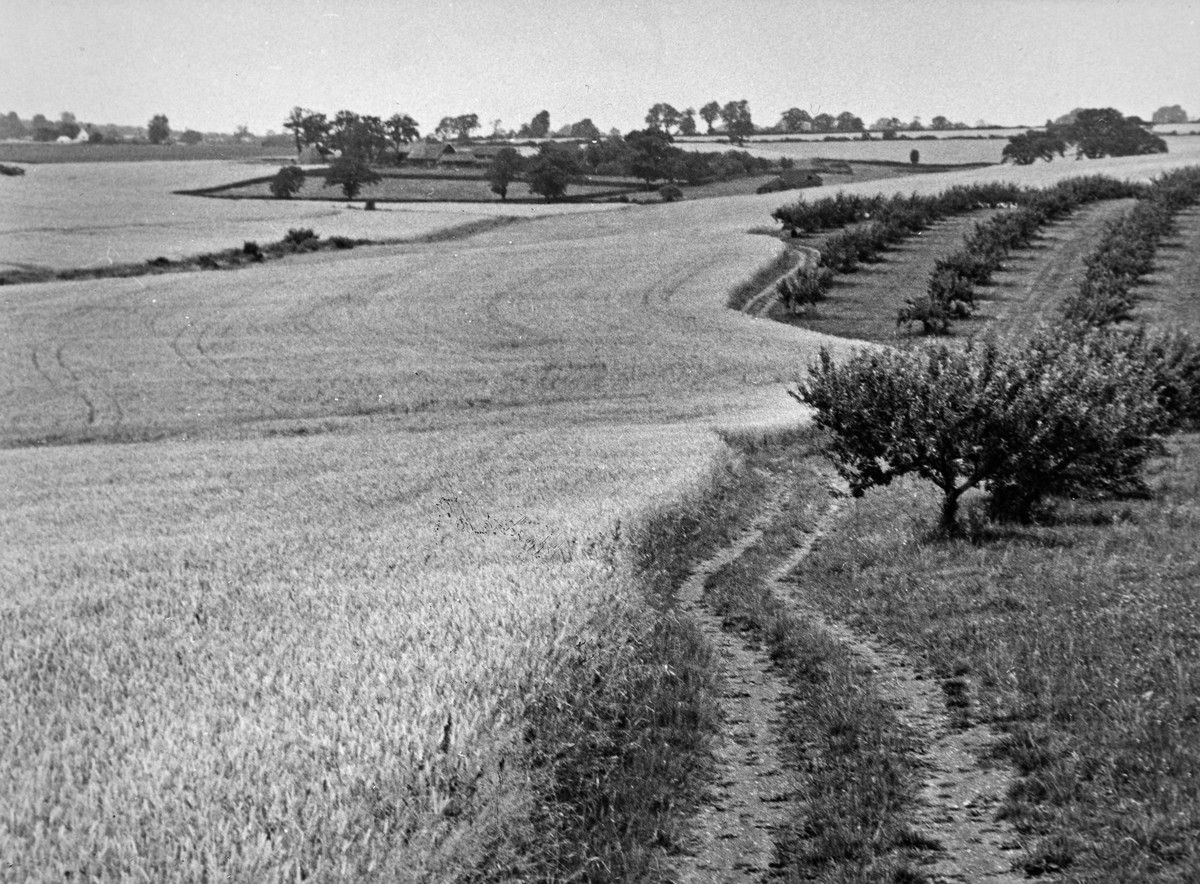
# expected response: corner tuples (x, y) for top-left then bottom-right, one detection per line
(478, 441), (764, 882)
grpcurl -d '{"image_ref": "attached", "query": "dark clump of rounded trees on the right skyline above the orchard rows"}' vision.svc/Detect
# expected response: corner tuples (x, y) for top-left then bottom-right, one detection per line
(1001, 108), (1166, 166)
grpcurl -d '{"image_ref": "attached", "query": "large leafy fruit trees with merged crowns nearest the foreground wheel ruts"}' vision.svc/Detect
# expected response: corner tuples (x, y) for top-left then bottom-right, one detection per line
(792, 327), (1163, 531)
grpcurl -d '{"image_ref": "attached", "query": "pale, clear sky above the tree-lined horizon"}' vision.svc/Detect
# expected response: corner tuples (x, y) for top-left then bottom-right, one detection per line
(0, 0), (1200, 134)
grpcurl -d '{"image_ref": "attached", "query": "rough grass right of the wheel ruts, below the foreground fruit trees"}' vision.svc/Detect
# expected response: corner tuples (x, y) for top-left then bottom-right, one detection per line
(782, 435), (1200, 882)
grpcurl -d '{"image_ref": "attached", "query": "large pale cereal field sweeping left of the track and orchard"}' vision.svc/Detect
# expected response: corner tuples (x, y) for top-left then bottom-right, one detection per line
(0, 148), (1194, 880)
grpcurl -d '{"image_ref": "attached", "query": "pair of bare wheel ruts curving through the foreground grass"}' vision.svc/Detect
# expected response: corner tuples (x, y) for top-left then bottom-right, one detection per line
(676, 482), (1026, 884)
